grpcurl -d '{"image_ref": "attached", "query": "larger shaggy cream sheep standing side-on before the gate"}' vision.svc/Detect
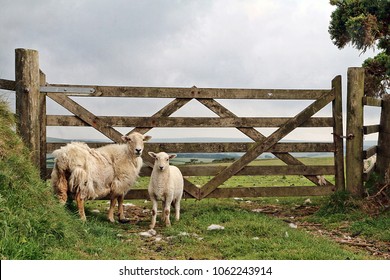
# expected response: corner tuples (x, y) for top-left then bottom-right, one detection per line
(51, 132), (151, 222)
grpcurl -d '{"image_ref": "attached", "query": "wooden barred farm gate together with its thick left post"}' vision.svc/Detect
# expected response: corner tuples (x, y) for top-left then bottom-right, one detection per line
(2, 49), (344, 199)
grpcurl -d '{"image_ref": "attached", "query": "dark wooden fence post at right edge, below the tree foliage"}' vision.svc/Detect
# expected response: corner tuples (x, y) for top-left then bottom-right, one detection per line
(376, 94), (390, 183)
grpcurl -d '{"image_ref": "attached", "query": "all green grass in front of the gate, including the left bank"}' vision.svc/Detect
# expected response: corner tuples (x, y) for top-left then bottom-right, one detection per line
(0, 99), (390, 260)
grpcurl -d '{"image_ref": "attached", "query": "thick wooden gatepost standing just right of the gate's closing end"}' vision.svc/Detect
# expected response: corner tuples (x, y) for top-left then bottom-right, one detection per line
(346, 67), (364, 197)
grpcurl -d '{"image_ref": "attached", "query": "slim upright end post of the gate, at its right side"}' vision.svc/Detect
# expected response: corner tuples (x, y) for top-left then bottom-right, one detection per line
(332, 76), (345, 190)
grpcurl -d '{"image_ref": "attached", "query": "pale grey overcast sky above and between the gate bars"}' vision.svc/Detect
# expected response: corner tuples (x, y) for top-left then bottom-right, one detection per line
(0, 0), (379, 141)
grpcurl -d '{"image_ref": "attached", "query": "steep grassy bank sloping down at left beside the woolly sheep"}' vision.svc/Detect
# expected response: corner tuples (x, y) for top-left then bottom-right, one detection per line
(0, 99), (137, 259)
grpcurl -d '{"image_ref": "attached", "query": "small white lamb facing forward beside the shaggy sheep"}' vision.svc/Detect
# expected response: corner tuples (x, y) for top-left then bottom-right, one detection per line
(148, 152), (184, 229)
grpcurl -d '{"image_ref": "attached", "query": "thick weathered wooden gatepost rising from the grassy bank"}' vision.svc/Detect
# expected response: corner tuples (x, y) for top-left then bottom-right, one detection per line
(15, 49), (40, 167)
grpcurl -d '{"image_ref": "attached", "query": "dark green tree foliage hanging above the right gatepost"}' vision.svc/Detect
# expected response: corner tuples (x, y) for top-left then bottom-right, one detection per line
(329, 0), (390, 96)
